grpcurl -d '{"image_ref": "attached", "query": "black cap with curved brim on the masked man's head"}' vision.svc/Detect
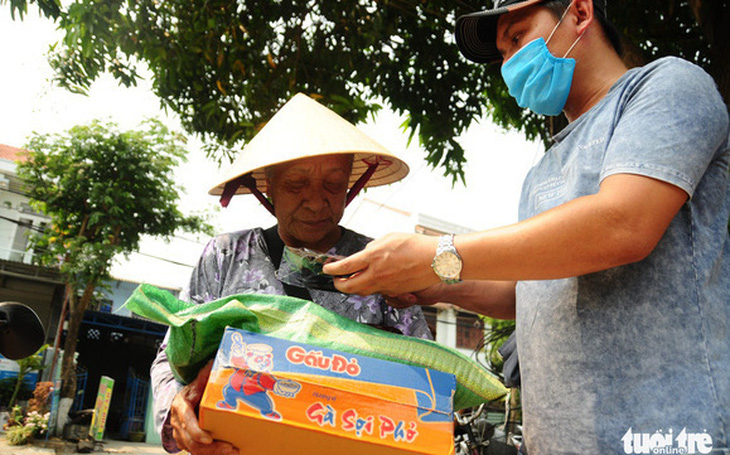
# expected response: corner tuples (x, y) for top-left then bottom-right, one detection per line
(455, 0), (606, 63)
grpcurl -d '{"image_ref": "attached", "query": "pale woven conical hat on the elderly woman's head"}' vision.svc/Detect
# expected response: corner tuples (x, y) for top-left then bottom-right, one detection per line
(208, 93), (408, 195)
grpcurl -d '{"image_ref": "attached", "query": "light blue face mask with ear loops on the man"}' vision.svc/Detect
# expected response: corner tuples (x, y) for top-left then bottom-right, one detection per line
(502, 5), (583, 116)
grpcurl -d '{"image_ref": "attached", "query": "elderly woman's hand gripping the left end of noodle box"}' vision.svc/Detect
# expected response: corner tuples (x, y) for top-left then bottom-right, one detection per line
(170, 359), (239, 455)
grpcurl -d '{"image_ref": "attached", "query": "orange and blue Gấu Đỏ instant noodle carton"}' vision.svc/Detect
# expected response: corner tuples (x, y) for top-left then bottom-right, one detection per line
(200, 327), (456, 455)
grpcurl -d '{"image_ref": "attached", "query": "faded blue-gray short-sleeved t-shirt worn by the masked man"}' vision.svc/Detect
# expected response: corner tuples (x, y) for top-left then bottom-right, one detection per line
(517, 58), (730, 455)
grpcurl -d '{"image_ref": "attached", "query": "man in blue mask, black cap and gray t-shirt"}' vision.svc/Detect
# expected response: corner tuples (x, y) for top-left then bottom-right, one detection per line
(325, 0), (730, 455)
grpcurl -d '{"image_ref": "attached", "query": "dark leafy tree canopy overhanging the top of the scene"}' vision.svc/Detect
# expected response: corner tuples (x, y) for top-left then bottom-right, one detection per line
(5, 0), (730, 179)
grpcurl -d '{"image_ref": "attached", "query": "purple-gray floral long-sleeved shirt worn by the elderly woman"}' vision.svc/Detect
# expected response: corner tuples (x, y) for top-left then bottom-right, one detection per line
(150, 228), (433, 453)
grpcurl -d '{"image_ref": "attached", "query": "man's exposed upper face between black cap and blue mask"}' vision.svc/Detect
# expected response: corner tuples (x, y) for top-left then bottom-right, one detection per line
(497, 5), (569, 62)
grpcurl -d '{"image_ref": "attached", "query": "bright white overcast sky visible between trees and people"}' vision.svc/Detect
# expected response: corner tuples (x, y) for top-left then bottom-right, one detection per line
(0, 8), (544, 285)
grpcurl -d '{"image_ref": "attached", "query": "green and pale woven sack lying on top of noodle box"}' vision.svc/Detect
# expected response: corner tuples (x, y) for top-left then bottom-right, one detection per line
(125, 284), (507, 410)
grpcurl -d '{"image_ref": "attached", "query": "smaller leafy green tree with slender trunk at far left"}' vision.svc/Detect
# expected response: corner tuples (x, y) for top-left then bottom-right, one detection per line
(18, 120), (209, 432)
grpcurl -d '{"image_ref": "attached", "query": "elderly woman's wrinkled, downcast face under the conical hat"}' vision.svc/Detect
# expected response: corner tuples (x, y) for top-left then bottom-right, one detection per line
(266, 155), (352, 251)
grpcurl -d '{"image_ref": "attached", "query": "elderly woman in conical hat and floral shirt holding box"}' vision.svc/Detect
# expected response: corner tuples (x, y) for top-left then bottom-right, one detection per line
(151, 94), (432, 454)
